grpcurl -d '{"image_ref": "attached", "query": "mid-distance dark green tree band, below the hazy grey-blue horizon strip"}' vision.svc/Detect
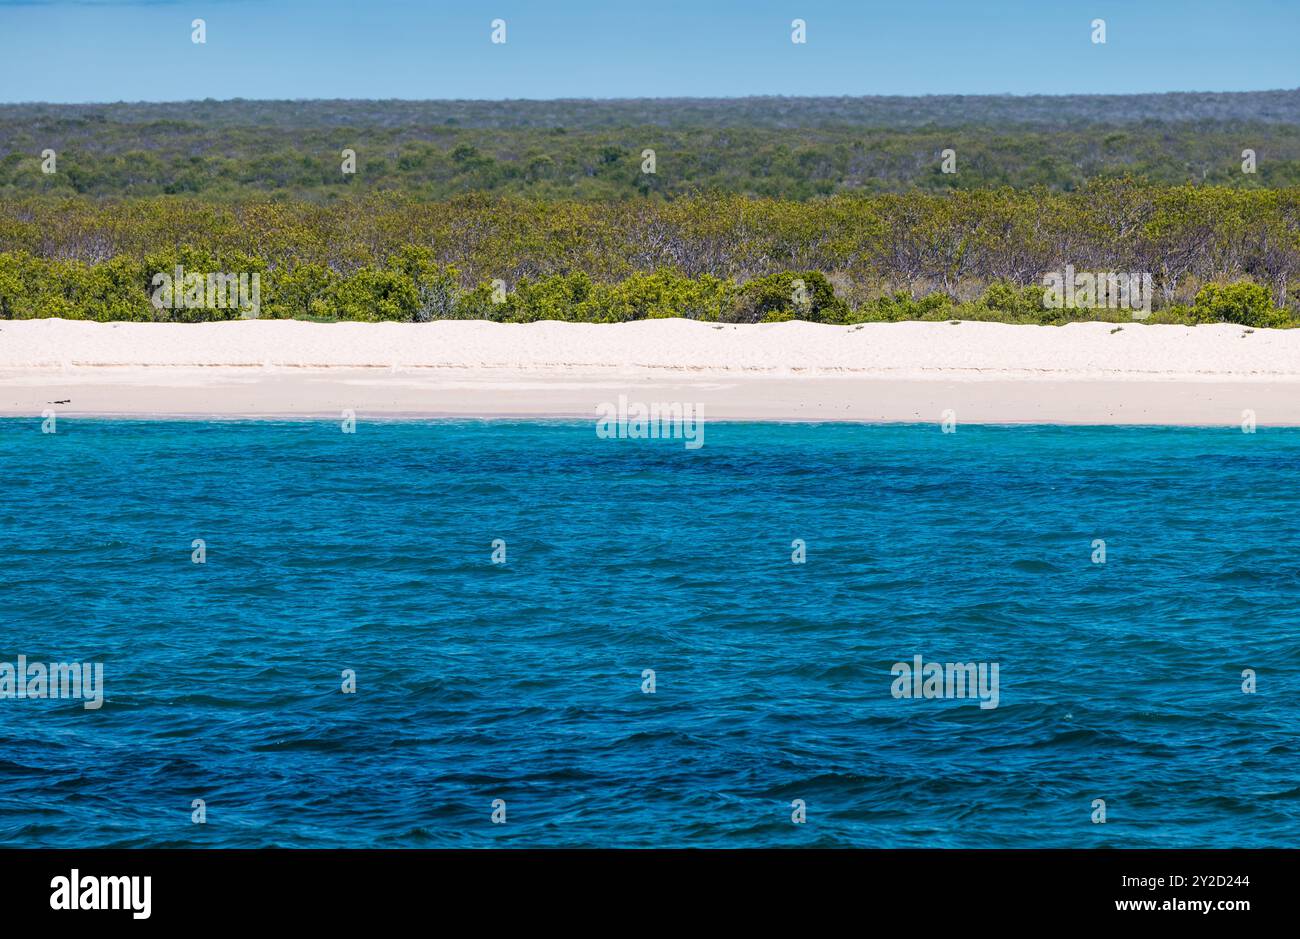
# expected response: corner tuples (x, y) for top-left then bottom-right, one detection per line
(0, 103), (1300, 202)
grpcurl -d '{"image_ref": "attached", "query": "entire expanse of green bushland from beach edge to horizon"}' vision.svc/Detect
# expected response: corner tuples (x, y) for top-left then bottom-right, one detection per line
(0, 91), (1300, 325)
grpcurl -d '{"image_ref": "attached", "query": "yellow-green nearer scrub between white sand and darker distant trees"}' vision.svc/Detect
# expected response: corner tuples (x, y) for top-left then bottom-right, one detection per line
(0, 181), (1300, 325)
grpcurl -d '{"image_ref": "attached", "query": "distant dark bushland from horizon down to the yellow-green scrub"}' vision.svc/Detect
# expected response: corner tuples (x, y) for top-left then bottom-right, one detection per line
(0, 92), (1300, 202)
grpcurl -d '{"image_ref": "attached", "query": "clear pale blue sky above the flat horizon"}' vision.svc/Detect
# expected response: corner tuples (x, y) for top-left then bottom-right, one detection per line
(0, 0), (1300, 101)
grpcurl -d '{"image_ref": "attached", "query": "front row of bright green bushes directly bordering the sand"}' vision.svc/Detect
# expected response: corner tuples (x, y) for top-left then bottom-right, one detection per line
(0, 248), (1300, 328)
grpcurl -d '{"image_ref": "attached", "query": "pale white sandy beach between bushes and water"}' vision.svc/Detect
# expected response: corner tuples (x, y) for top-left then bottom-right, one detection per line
(0, 320), (1300, 425)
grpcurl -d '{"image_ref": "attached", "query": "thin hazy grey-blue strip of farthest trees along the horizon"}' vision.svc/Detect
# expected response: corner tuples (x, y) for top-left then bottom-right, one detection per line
(10, 88), (1300, 130)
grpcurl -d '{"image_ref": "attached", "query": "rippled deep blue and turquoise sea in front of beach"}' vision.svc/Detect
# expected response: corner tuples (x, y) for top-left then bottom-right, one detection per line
(0, 419), (1300, 847)
